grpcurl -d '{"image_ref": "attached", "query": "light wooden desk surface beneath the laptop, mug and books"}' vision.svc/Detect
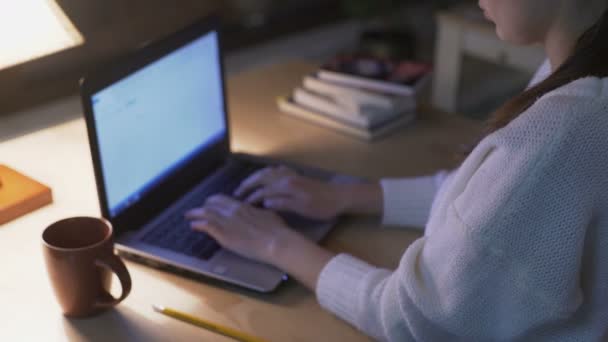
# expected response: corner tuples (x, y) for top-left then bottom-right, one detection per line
(0, 63), (479, 341)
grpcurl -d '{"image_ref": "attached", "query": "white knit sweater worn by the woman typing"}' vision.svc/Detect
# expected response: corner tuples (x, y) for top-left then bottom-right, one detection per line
(316, 65), (608, 341)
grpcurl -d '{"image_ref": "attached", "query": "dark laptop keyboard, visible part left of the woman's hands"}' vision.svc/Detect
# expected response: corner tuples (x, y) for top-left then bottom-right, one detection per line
(142, 164), (260, 260)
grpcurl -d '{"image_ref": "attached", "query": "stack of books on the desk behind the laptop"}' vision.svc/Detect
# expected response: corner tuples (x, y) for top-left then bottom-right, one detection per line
(278, 56), (431, 140)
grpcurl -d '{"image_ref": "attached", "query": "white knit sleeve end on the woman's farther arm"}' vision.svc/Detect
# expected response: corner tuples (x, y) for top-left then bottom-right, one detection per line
(380, 170), (449, 227)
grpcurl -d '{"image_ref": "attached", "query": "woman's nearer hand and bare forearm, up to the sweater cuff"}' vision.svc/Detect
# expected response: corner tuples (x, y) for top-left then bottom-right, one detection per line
(186, 195), (334, 291)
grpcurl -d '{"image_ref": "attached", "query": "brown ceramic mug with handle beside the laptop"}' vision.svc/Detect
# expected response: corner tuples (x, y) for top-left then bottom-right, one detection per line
(42, 217), (131, 317)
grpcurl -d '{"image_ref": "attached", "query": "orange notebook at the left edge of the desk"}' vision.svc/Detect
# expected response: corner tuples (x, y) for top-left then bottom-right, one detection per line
(0, 165), (53, 225)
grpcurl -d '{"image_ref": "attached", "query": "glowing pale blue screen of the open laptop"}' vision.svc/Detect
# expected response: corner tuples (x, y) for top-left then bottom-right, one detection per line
(91, 31), (226, 217)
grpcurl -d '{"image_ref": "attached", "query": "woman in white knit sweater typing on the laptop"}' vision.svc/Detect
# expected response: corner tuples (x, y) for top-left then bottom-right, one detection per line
(188, 0), (608, 341)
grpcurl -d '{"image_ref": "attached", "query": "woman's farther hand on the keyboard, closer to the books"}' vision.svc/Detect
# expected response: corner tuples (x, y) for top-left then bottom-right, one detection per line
(234, 166), (347, 220)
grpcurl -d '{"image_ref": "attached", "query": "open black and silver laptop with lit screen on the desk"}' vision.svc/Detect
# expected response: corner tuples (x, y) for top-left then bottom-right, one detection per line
(81, 18), (339, 292)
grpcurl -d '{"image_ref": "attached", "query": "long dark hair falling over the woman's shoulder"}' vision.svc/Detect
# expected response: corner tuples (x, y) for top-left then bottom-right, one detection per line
(462, 9), (608, 157)
